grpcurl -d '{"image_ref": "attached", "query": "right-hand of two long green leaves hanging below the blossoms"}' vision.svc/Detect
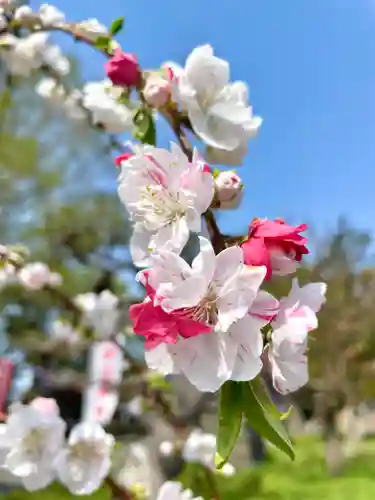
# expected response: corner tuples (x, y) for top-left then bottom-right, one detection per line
(242, 377), (295, 460)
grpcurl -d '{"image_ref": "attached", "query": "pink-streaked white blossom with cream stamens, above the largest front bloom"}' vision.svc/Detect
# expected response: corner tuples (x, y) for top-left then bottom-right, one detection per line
(118, 144), (214, 267)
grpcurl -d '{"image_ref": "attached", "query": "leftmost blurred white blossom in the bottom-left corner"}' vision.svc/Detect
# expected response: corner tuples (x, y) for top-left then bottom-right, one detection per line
(5, 398), (65, 491)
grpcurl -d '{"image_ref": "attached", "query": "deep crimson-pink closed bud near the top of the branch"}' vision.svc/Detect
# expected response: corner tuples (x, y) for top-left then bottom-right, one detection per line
(105, 49), (141, 87)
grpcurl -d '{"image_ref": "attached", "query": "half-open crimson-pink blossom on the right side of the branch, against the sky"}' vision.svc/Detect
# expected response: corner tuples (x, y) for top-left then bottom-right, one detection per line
(241, 219), (309, 280)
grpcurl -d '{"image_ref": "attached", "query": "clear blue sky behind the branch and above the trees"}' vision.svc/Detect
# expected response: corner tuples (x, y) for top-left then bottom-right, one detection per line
(32, 0), (375, 238)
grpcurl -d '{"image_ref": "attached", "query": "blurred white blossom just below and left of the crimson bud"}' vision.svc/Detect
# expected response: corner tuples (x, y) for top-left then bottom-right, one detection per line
(83, 81), (133, 134)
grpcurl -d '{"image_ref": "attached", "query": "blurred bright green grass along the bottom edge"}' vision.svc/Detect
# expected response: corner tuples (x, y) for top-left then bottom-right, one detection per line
(0, 437), (375, 500)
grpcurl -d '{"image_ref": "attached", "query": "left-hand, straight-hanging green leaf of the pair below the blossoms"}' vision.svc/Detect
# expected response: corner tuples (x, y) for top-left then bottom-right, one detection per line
(215, 381), (242, 469)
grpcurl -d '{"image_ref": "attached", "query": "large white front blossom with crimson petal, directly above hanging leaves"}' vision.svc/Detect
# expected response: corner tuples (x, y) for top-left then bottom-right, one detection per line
(140, 237), (268, 392)
